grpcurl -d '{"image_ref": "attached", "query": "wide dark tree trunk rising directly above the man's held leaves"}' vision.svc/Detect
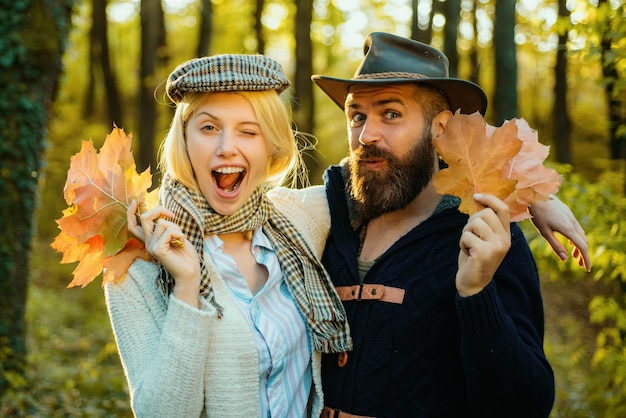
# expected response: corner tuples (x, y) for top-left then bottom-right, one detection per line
(491, 0), (518, 126)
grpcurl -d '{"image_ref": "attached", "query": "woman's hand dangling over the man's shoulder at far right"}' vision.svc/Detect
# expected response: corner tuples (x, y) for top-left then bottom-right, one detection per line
(530, 196), (591, 271)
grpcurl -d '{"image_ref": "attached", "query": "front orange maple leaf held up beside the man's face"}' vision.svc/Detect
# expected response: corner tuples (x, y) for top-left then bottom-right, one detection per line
(433, 112), (522, 215)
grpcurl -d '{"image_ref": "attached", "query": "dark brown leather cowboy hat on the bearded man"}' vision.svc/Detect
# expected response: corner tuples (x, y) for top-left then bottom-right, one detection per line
(311, 32), (487, 115)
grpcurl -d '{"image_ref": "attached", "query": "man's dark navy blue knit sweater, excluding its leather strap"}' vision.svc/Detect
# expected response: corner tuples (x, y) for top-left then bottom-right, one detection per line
(322, 166), (554, 418)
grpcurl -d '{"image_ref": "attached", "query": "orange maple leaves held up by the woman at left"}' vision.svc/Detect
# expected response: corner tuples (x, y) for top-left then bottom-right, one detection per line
(51, 127), (156, 287)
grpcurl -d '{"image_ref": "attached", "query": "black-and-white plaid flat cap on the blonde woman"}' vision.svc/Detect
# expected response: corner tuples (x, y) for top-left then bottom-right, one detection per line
(165, 54), (290, 103)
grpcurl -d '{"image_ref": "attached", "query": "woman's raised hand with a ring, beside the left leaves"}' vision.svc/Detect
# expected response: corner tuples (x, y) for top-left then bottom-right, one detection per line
(126, 202), (200, 306)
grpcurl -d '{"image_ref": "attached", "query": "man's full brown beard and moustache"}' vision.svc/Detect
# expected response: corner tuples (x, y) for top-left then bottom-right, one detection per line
(349, 129), (435, 221)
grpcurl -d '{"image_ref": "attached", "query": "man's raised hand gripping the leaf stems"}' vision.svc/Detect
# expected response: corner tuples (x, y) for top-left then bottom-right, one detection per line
(456, 194), (511, 297)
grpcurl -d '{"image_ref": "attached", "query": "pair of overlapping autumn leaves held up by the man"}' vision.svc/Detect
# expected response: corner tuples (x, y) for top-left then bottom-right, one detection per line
(433, 112), (561, 222)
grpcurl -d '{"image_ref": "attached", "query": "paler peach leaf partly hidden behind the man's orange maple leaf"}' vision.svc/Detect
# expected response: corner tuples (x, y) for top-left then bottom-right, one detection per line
(494, 119), (563, 222)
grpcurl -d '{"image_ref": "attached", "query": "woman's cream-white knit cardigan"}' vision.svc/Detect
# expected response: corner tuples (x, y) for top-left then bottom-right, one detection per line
(104, 186), (330, 418)
